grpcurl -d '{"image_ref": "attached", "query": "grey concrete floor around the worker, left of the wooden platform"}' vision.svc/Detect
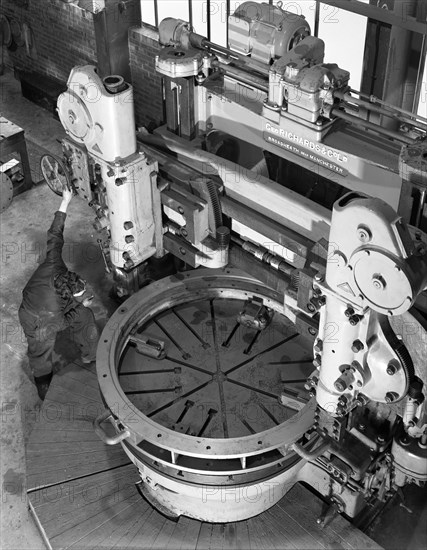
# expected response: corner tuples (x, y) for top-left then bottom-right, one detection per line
(0, 73), (115, 550)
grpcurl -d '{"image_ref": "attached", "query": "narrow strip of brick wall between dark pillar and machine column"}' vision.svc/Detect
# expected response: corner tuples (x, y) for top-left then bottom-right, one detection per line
(129, 25), (164, 128)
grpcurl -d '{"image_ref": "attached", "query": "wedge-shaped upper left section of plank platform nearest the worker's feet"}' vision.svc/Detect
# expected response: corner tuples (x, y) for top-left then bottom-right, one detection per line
(26, 363), (130, 490)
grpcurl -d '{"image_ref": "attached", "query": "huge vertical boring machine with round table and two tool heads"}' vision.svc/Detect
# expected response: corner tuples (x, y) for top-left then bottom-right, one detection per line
(42, 2), (427, 532)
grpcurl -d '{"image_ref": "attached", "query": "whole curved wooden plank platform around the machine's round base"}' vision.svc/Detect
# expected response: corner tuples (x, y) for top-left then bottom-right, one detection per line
(27, 363), (380, 550)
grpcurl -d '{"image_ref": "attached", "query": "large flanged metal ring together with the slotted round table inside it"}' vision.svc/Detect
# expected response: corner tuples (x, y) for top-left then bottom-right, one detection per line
(97, 269), (314, 492)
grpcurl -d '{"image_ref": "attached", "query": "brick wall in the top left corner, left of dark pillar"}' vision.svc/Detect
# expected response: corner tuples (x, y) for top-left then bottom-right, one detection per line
(0, 0), (96, 82)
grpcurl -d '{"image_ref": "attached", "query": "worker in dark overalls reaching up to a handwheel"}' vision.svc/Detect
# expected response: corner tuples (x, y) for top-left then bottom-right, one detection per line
(19, 189), (99, 400)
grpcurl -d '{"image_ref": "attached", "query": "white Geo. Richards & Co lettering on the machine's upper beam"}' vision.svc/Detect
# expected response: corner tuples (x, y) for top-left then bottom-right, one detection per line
(263, 122), (348, 176)
